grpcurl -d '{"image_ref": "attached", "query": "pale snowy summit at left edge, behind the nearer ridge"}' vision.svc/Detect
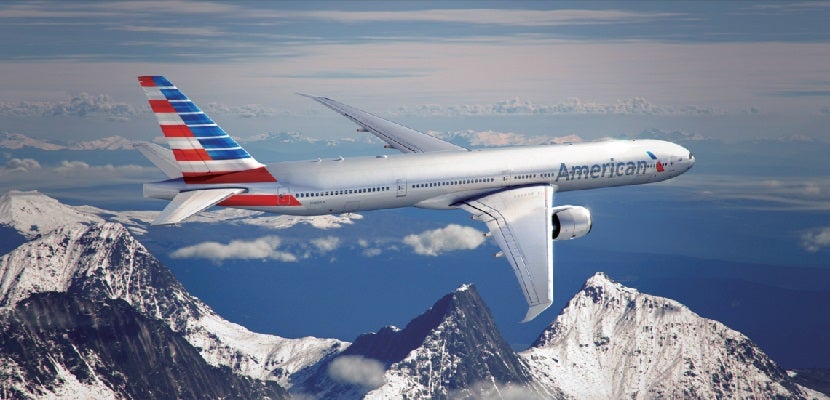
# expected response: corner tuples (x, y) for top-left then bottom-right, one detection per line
(0, 190), (104, 239)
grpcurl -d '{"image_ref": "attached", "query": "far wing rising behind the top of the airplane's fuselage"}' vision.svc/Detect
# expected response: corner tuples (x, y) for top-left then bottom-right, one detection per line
(300, 93), (467, 153)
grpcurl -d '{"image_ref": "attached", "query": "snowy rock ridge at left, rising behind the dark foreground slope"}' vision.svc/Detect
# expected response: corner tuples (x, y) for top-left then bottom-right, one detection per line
(0, 219), (344, 387)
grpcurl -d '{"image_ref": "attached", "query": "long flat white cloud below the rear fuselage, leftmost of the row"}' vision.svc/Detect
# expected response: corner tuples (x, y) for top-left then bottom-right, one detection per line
(171, 236), (297, 262)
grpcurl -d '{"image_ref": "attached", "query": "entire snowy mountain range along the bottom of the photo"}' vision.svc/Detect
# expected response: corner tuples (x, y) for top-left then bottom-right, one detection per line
(0, 192), (828, 399)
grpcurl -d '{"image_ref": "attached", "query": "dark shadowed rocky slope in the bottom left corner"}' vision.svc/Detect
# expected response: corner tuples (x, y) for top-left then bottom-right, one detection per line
(0, 292), (288, 400)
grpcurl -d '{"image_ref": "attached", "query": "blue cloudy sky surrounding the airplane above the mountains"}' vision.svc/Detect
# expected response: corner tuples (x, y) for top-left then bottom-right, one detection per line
(0, 1), (830, 365)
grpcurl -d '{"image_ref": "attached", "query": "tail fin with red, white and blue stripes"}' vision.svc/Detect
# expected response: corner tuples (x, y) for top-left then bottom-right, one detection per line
(138, 76), (276, 184)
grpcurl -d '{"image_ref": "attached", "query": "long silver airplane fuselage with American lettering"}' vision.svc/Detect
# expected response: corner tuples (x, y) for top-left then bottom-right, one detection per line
(144, 140), (695, 215)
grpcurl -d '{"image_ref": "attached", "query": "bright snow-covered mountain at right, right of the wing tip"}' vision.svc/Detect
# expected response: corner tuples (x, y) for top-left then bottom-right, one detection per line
(521, 273), (820, 399)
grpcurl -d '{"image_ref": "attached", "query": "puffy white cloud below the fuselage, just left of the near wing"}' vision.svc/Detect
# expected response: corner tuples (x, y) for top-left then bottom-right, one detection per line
(403, 224), (485, 256)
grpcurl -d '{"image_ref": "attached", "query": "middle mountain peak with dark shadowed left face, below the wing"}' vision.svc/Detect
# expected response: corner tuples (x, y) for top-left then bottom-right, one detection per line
(305, 286), (561, 399)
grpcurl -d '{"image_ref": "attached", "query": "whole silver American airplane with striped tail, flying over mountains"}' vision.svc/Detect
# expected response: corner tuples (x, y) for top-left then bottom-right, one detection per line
(135, 76), (695, 322)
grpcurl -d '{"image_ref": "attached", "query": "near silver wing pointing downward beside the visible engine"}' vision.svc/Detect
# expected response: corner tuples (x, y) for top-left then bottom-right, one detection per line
(461, 185), (555, 322)
